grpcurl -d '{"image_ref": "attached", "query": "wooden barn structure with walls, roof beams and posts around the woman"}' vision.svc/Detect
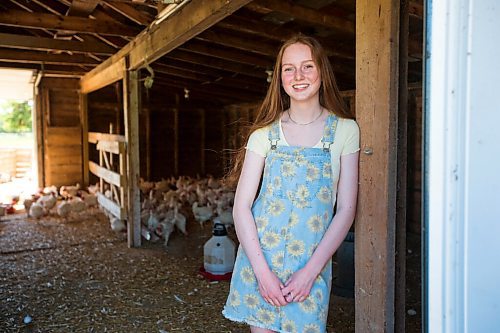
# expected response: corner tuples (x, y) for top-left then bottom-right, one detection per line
(0, 0), (424, 332)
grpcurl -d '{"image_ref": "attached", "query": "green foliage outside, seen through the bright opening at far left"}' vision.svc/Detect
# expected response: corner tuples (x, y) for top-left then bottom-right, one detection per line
(0, 101), (31, 133)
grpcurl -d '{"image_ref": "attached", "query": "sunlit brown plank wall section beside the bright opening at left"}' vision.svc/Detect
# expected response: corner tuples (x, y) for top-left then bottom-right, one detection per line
(38, 78), (82, 186)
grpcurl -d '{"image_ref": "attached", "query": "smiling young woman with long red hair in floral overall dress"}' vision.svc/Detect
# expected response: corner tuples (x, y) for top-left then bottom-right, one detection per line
(223, 35), (359, 333)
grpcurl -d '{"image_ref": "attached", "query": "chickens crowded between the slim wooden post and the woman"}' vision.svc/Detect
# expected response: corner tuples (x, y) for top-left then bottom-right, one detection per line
(139, 176), (234, 245)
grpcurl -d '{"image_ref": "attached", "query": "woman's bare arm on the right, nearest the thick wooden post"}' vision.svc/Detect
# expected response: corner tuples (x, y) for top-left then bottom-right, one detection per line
(283, 152), (359, 302)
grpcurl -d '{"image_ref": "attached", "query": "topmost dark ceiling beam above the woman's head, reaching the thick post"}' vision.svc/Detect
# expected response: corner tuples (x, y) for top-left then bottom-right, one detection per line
(246, 0), (355, 35)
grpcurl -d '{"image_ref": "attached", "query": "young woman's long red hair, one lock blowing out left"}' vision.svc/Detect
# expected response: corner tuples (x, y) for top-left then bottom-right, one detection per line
(225, 34), (354, 186)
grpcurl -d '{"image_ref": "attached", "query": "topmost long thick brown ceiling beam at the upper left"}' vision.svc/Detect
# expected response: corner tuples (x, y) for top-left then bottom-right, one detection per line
(0, 10), (139, 37)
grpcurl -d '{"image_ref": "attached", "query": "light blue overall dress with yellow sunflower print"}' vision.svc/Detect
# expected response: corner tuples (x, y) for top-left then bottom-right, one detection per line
(223, 114), (338, 333)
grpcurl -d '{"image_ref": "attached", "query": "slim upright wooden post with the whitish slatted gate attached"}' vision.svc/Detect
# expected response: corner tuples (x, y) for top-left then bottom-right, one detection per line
(123, 65), (141, 247)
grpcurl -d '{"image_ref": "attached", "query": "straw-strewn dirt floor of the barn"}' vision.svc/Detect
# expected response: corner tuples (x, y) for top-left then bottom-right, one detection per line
(0, 209), (421, 333)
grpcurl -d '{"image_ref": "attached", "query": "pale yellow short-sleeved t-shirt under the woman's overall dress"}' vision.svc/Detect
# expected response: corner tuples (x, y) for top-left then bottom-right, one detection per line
(246, 118), (359, 204)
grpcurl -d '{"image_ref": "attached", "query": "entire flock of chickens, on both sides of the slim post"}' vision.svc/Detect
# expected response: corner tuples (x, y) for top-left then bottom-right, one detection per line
(23, 176), (234, 245)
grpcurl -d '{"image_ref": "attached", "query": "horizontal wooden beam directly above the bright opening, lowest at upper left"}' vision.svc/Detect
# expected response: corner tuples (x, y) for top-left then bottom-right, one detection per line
(0, 48), (98, 66)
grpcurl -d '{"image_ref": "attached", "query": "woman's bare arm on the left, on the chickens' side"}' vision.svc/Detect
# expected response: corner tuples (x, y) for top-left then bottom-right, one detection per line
(233, 150), (287, 306)
